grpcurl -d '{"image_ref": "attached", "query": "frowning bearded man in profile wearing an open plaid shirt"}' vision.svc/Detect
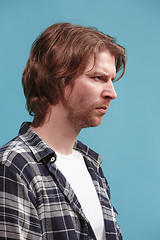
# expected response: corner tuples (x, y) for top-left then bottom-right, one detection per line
(0, 23), (125, 240)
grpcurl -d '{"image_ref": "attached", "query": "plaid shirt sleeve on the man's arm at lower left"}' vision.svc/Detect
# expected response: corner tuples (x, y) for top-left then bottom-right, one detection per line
(0, 165), (42, 240)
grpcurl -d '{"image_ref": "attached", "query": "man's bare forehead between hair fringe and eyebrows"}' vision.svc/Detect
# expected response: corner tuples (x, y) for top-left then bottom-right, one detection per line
(84, 51), (116, 76)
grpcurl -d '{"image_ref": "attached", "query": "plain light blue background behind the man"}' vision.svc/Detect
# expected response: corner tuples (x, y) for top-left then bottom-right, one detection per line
(0, 0), (160, 240)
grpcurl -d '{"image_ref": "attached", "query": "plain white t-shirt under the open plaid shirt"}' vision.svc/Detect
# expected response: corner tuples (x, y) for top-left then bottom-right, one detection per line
(56, 150), (105, 240)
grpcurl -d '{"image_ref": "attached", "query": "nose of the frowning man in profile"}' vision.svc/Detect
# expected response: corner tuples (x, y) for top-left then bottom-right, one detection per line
(102, 80), (117, 99)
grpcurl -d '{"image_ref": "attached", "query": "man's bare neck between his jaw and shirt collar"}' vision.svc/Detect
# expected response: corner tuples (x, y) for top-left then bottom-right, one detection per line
(32, 105), (80, 155)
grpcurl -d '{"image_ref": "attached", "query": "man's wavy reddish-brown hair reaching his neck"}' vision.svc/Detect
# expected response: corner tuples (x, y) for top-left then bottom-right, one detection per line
(22, 23), (126, 127)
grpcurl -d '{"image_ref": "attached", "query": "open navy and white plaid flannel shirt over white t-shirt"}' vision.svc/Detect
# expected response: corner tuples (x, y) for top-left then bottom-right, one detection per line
(0, 123), (122, 240)
